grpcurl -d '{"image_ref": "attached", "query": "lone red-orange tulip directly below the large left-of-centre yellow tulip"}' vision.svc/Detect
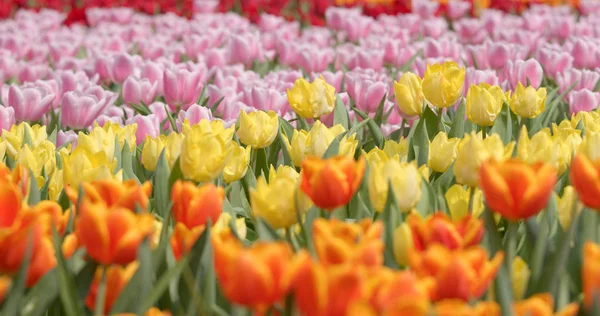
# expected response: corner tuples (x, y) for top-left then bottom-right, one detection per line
(171, 181), (225, 229)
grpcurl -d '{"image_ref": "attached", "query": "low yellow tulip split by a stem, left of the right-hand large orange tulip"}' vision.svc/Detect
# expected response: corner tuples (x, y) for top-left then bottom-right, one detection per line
(444, 184), (483, 221)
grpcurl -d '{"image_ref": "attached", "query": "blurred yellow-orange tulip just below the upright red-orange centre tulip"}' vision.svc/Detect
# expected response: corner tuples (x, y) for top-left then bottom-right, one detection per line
(313, 219), (385, 266)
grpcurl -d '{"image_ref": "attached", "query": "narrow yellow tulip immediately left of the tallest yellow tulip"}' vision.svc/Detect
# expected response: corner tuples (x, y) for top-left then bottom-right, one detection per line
(394, 72), (423, 116)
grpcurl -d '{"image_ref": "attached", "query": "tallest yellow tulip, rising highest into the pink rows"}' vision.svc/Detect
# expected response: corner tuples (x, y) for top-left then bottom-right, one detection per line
(423, 61), (465, 108)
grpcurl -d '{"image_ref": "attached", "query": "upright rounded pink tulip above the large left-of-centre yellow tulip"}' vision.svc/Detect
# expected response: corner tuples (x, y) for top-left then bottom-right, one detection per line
(163, 69), (204, 111)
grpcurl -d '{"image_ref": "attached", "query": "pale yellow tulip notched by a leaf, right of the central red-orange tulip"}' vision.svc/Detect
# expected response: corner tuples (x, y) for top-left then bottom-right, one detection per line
(368, 159), (422, 212)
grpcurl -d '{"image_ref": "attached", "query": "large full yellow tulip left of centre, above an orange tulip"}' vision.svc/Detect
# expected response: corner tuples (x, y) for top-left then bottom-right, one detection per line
(179, 120), (234, 182)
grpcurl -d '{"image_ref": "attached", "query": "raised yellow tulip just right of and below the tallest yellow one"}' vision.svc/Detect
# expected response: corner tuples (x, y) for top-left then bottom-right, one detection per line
(466, 83), (506, 126)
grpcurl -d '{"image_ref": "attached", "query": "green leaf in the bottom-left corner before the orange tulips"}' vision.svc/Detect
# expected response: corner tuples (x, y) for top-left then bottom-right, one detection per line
(0, 230), (33, 315)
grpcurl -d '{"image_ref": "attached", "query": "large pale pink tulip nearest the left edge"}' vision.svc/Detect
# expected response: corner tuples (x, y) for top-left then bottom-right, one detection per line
(7, 81), (56, 122)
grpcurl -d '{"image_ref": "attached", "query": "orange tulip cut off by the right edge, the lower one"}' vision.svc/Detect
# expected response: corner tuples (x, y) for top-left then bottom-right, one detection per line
(581, 241), (600, 308)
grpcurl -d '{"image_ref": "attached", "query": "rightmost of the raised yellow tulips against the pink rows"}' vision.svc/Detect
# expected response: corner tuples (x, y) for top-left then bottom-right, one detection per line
(509, 82), (546, 118)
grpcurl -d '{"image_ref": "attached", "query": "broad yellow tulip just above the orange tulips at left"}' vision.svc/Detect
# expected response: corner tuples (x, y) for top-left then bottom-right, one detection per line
(60, 147), (123, 188)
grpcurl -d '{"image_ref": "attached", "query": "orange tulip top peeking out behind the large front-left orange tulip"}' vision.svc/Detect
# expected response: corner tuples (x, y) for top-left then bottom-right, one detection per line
(65, 179), (152, 211)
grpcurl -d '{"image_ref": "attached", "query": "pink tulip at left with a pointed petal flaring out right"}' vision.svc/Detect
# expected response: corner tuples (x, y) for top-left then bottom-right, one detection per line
(60, 91), (112, 130)
